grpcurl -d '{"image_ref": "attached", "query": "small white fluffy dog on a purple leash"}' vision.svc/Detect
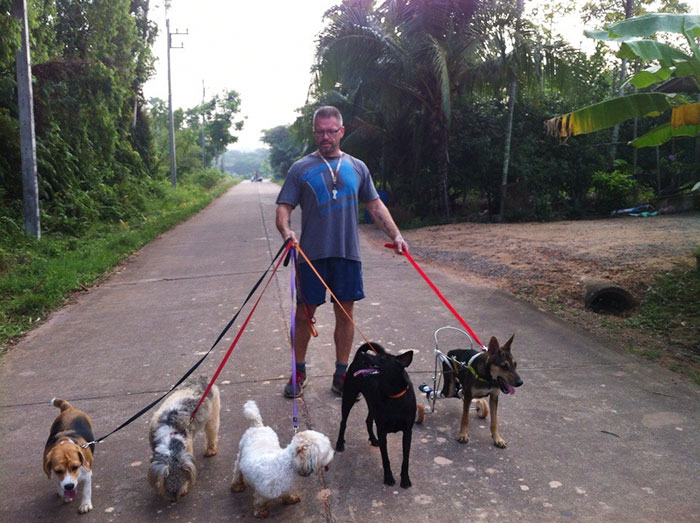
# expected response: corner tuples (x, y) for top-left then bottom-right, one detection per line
(231, 400), (333, 518)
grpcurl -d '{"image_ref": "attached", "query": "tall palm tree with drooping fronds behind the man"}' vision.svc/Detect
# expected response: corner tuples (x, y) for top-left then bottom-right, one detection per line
(316, 0), (481, 221)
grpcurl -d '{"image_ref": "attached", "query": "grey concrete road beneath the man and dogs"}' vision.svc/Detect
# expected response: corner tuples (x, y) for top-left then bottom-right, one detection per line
(0, 183), (700, 522)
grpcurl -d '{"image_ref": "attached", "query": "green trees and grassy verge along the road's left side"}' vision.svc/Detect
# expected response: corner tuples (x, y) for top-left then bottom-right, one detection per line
(0, 0), (243, 350)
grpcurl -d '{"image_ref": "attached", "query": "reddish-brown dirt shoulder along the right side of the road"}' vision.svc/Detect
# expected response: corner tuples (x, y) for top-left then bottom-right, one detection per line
(367, 213), (700, 380)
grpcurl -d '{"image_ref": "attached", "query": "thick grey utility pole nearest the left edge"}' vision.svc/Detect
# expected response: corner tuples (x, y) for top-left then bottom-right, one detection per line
(12, 0), (41, 240)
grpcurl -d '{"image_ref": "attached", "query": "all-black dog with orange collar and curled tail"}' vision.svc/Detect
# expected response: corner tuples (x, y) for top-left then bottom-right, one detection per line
(335, 343), (416, 488)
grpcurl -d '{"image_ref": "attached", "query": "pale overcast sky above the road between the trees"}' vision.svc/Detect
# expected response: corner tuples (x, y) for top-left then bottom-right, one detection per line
(144, 0), (336, 149)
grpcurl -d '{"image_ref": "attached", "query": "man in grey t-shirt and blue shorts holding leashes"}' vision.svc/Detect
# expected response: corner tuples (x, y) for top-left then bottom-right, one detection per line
(277, 106), (408, 398)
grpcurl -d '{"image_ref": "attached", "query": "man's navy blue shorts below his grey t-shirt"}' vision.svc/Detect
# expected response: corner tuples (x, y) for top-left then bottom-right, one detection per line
(297, 258), (365, 305)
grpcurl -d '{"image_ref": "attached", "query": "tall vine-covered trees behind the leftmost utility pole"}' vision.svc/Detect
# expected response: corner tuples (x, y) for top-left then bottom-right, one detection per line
(0, 0), (155, 234)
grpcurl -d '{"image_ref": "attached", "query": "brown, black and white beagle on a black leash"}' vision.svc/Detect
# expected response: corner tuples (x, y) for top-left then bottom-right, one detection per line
(44, 398), (95, 514)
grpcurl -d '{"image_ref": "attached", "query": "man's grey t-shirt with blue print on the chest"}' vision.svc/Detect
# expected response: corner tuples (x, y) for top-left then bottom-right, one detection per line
(277, 153), (379, 261)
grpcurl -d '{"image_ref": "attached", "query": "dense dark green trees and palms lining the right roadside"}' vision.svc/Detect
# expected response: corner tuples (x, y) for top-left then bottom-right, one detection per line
(264, 0), (700, 227)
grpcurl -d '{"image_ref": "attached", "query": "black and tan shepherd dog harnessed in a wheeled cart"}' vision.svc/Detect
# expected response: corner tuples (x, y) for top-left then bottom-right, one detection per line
(442, 335), (523, 449)
